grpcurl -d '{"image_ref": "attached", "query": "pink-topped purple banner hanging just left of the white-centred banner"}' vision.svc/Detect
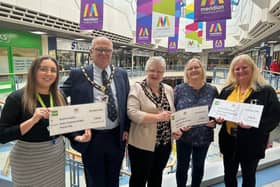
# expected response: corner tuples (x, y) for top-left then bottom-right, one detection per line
(136, 0), (153, 44)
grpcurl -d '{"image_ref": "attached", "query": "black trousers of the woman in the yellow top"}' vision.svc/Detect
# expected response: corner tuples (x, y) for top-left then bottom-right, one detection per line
(223, 154), (259, 187)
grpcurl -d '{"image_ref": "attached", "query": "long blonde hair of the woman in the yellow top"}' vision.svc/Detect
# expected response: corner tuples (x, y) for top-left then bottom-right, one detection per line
(226, 54), (267, 90)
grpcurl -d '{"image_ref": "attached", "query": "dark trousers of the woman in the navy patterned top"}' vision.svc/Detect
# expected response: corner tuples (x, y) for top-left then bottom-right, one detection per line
(176, 140), (210, 187)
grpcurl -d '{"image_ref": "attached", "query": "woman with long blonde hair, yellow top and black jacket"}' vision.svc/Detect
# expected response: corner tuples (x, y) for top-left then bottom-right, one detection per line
(216, 54), (280, 187)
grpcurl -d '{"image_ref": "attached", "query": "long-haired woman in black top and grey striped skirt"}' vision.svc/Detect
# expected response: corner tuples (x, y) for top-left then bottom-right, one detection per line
(0, 56), (91, 187)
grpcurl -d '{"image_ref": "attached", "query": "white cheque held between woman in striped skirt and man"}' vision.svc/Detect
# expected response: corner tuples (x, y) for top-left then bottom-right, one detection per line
(49, 102), (107, 136)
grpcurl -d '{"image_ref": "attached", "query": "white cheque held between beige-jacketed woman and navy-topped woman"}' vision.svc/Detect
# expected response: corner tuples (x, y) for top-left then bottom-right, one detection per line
(171, 105), (209, 132)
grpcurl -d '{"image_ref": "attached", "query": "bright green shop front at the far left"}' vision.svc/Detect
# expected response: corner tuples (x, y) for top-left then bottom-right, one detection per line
(0, 29), (42, 94)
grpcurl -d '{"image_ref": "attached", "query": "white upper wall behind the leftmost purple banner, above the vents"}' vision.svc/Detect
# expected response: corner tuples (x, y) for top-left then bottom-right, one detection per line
(0, 0), (136, 37)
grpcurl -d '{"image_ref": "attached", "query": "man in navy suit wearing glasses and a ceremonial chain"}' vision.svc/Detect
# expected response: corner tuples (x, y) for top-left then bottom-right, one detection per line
(62, 37), (130, 187)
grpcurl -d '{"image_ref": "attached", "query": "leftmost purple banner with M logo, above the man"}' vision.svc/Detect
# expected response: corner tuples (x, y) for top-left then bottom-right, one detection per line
(80, 0), (103, 30)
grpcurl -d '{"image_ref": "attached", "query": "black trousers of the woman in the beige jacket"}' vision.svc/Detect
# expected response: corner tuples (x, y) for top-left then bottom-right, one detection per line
(128, 144), (171, 187)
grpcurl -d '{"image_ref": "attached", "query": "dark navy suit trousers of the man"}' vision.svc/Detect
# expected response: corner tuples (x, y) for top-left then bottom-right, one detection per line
(83, 129), (124, 187)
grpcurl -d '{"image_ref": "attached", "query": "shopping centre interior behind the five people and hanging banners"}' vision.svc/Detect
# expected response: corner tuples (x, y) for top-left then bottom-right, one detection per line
(0, 0), (280, 187)
